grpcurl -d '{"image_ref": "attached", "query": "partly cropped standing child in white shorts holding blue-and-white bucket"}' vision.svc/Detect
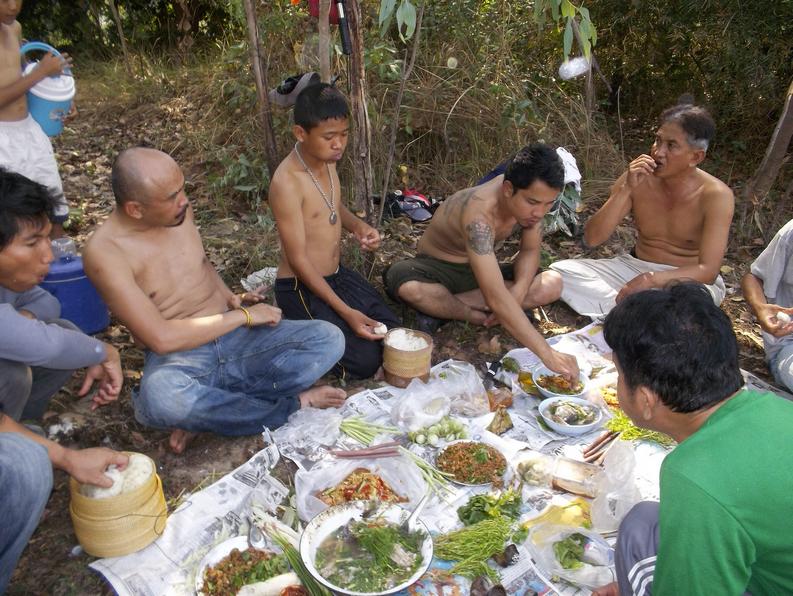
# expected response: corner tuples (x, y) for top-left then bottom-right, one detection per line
(0, 0), (71, 238)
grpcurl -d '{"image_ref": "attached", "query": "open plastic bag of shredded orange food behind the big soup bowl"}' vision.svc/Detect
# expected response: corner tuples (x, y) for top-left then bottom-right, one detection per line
(295, 455), (427, 521)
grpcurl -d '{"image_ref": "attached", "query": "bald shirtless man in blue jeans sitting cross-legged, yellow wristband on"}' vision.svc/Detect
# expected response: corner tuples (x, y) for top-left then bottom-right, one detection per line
(84, 148), (345, 453)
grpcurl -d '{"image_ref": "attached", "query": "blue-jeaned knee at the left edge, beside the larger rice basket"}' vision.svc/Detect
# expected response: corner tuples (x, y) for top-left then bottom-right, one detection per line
(0, 432), (52, 594)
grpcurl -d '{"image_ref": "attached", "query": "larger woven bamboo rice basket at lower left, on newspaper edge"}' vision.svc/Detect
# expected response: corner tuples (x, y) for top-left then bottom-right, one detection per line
(69, 454), (168, 557)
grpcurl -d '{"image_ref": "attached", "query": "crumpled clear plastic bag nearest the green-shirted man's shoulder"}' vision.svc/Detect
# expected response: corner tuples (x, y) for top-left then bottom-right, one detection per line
(592, 439), (642, 532)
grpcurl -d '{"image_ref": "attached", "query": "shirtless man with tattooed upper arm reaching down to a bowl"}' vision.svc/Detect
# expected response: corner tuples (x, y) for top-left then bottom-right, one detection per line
(384, 143), (578, 377)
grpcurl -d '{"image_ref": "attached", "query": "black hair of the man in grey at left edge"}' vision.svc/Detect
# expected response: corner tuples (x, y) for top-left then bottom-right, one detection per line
(0, 168), (58, 250)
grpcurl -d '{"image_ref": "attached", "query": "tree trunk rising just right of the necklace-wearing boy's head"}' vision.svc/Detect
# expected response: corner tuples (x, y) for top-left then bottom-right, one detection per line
(345, 0), (374, 219)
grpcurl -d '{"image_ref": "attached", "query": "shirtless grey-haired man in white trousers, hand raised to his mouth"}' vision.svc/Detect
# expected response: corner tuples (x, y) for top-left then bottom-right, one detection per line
(551, 104), (734, 318)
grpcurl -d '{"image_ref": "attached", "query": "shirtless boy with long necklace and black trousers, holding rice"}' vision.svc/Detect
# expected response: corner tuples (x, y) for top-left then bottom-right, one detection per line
(269, 83), (399, 379)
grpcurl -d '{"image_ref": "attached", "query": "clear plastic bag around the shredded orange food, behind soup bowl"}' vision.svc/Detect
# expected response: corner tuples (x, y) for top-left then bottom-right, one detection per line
(295, 455), (427, 521)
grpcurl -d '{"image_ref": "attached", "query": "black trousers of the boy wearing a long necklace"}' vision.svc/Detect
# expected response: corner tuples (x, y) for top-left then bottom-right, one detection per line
(275, 266), (401, 379)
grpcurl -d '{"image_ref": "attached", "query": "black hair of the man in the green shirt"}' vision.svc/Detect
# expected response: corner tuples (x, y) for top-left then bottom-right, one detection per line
(603, 282), (743, 413)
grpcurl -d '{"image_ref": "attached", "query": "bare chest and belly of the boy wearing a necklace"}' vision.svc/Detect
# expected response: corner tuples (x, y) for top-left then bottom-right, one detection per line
(270, 151), (342, 277)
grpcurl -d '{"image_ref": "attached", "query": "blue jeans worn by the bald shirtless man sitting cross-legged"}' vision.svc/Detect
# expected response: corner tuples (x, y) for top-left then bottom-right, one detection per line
(133, 320), (344, 436)
